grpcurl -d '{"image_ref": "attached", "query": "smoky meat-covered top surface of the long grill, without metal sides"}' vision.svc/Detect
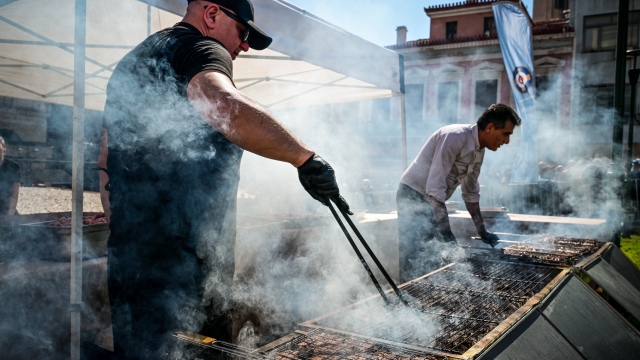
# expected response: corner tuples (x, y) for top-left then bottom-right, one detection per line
(178, 234), (630, 360)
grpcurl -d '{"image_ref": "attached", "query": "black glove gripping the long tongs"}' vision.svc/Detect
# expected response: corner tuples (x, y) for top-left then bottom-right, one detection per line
(298, 154), (353, 215)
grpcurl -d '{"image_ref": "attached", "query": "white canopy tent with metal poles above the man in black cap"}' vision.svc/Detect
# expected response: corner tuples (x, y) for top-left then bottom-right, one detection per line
(0, 0), (406, 359)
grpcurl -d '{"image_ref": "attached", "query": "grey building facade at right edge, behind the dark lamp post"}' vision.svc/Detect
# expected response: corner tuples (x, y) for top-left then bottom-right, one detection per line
(571, 0), (640, 158)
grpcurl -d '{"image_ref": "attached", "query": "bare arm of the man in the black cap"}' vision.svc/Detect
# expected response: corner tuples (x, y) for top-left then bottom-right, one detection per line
(187, 71), (313, 167)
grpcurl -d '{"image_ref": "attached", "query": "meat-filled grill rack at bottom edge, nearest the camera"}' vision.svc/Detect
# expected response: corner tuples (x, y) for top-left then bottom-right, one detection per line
(269, 329), (446, 360)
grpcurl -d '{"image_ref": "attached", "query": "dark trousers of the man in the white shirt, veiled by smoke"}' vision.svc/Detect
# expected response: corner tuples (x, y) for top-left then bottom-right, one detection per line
(396, 184), (455, 283)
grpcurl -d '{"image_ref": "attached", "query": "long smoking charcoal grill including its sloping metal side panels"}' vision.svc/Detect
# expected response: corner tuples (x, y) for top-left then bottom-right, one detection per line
(251, 239), (640, 359)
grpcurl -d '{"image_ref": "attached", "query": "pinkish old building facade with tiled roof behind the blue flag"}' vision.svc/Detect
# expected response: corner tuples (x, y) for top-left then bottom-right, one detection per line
(390, 0), (574, 166)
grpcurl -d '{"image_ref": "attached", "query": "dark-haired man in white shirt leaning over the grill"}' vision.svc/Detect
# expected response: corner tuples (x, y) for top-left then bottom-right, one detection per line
(396, 104), (520, 282)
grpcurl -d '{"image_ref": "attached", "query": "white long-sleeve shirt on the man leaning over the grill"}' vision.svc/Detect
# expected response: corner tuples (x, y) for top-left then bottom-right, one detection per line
(400, 124), (484, 203)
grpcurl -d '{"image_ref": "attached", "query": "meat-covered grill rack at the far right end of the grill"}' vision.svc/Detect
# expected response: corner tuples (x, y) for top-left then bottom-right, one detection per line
(503, 235), (602, 266)
